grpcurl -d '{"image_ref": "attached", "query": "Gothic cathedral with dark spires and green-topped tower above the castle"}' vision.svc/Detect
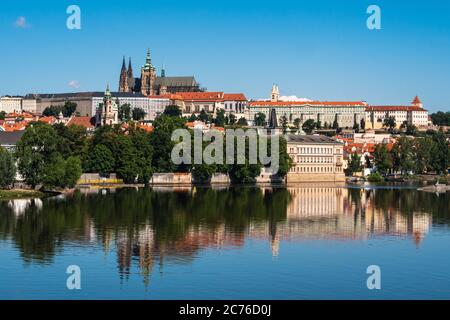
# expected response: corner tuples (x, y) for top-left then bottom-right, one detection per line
(119, 50), (204, 97)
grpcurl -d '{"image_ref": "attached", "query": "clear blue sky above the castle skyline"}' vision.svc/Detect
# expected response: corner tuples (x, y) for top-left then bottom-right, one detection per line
(0, 0), (450, 111)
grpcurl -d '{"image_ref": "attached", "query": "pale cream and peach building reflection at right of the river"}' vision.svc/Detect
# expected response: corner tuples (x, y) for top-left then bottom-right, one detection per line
(249, 186), (432, 255)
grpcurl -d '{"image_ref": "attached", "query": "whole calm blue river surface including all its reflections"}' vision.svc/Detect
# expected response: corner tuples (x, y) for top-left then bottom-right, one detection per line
(0, 185), (450, 299)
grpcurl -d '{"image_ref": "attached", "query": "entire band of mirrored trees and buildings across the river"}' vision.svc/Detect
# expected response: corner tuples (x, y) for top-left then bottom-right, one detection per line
(0, 185), (450, 283)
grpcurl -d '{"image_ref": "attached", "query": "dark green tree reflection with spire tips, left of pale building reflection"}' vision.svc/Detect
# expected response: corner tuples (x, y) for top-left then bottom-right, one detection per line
(0, 188), (289, 282)
